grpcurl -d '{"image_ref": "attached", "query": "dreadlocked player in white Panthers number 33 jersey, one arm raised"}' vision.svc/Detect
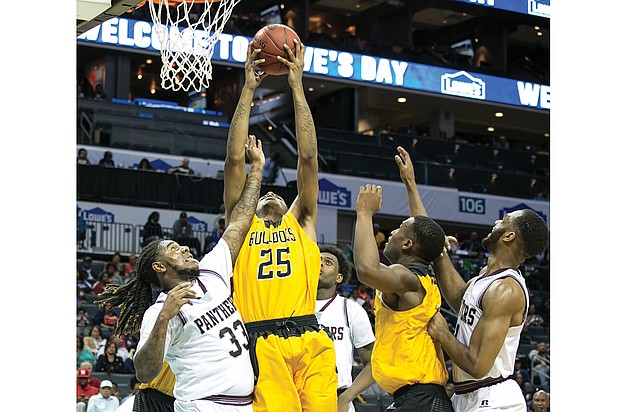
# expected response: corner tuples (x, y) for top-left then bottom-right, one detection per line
(95, 136), (265, 412)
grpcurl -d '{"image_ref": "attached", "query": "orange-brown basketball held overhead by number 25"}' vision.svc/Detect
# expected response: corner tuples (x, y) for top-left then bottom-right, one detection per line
(252, 24), (301, 76)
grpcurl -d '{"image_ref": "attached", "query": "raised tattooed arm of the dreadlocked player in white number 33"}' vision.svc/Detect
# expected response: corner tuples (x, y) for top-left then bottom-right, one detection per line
(222, 136), (265, 263)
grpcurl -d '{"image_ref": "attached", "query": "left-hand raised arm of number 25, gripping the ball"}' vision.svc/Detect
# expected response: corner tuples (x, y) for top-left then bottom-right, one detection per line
(224, 43), (267, 224)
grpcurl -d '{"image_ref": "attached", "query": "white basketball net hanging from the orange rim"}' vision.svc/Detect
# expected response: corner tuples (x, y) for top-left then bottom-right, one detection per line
(148, 0), (240, 91)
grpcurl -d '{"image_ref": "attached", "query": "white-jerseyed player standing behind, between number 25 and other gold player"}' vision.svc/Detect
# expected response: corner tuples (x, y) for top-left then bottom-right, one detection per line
(316, 245), (375, 412)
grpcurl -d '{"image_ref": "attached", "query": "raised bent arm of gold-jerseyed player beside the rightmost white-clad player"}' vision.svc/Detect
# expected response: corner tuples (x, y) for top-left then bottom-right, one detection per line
(353, 184), (420, 293)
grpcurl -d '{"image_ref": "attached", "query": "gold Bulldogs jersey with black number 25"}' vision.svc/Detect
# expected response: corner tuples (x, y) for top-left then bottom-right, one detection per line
(233, 211), (321, 323)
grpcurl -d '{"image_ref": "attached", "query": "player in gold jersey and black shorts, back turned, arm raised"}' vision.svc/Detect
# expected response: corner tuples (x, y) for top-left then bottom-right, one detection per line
(353, 184), (453, 412)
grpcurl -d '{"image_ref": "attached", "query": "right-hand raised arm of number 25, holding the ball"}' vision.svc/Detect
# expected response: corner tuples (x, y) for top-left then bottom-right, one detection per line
(278, 39), (319, 233)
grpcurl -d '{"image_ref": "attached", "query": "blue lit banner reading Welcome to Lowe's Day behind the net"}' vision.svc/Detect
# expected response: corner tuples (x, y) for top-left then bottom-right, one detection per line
(78, 18), (551, 110)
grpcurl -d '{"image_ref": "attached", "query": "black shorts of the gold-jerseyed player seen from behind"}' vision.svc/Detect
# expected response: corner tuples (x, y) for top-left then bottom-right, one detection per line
(385, 383), (454, 412)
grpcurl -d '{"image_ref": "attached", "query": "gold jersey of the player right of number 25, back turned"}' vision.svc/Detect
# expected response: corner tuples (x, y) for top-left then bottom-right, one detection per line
(371, 271), (448, 393)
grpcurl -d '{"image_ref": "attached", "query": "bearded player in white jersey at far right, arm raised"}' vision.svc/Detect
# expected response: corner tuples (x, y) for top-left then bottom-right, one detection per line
(396, 148), (549, 412)
